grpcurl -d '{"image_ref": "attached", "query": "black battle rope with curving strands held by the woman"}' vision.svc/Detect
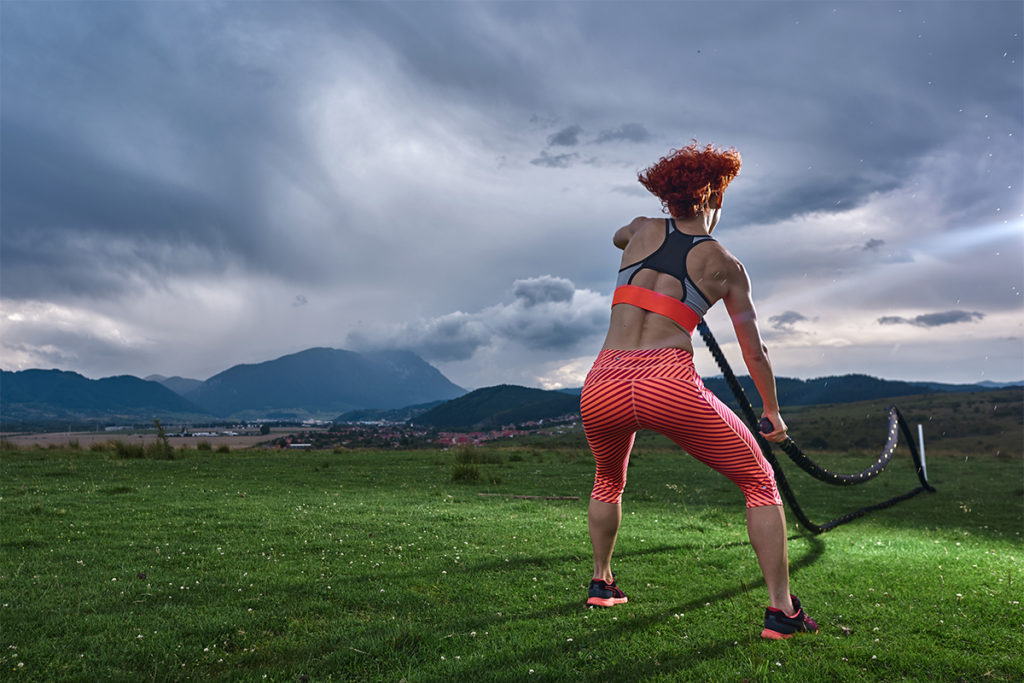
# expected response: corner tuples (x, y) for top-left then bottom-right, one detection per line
(697, 321), (935, 533)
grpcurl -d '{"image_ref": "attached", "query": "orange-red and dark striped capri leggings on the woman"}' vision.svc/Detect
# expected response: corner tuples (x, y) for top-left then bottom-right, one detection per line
(580, 348), (782, 508)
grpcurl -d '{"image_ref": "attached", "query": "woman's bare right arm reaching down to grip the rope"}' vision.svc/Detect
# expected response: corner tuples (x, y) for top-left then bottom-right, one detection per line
(723, 259), (786, 442)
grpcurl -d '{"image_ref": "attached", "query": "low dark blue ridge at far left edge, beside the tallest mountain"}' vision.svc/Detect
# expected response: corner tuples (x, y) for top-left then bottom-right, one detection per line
(0, 370), (210, 429)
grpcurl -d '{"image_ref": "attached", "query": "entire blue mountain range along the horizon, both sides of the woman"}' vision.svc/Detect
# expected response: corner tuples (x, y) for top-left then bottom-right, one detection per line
(0, 348), (1020, 430)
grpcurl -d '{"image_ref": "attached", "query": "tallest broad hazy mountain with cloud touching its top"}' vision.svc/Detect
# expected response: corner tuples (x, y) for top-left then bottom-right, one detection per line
(186, 348), (466, 418)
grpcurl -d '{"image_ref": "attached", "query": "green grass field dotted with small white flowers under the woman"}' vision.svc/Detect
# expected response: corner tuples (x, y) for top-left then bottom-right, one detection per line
(0, 441), (1024, 682)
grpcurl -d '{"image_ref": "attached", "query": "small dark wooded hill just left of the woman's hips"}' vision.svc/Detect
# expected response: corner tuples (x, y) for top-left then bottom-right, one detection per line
(414, 384), (580, 431)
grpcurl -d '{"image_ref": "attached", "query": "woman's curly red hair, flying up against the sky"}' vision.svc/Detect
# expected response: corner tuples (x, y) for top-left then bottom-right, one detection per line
(637, 140), (741, 218)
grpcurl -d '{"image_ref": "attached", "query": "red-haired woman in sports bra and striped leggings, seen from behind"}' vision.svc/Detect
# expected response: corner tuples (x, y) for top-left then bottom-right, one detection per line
(581, 140), (817, 638)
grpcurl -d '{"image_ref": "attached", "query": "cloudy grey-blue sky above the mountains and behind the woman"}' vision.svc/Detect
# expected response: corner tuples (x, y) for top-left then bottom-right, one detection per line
(0, 0), (1024, 389)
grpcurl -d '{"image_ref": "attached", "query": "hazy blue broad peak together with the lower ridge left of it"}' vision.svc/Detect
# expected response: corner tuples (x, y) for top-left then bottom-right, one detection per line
(0, 348), (466, 429)
